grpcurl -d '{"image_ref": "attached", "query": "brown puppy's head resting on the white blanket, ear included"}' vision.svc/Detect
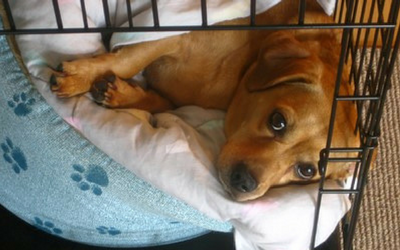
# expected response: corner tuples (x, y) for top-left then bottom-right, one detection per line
(217, 31), (358, 201)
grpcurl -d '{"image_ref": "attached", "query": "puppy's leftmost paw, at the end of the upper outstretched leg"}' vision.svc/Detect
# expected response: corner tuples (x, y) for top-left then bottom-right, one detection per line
(49, 60), (95, 98)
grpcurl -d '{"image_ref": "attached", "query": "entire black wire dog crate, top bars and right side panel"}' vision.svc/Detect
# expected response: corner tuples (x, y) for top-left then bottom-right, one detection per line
(0, 0), (400, 250)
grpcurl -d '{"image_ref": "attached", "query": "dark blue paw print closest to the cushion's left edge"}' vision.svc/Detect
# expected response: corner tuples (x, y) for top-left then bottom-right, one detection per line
(1, 137), (28, 174)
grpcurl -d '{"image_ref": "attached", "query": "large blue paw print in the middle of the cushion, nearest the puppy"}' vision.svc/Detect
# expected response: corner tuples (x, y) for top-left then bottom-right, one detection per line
(71, 164), (108, 195)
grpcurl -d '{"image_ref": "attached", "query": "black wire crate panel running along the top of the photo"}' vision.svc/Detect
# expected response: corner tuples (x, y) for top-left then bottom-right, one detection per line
(0, 0), (397, 34)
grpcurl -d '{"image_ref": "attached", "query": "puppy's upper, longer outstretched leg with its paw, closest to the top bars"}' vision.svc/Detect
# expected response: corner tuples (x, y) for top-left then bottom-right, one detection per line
(50, 36), (180, 97)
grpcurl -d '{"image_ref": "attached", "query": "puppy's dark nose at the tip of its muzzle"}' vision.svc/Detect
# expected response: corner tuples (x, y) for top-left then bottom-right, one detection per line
(230, 163), (258, 193)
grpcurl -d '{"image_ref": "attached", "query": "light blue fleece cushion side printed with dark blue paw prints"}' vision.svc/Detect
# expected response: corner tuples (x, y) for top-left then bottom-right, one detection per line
(0, 20), (232, 247)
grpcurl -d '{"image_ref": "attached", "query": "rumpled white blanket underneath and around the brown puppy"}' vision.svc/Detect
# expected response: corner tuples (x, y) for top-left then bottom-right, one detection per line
(10, 0), (350, 250)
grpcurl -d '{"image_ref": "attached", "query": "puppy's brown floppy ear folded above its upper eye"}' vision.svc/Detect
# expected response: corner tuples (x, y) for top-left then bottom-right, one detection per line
(245, 31), (320, 92)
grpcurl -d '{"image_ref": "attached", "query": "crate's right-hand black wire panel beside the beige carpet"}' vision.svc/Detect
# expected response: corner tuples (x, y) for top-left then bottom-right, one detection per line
(322, 0), (399, 249)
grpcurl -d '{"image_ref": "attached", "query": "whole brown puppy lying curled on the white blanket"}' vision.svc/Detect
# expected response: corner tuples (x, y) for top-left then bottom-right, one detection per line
(50, 0), (357, 201)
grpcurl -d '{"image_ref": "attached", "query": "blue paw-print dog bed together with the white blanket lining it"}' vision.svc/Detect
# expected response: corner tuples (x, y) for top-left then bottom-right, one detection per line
(0, 0), (349, 250)
